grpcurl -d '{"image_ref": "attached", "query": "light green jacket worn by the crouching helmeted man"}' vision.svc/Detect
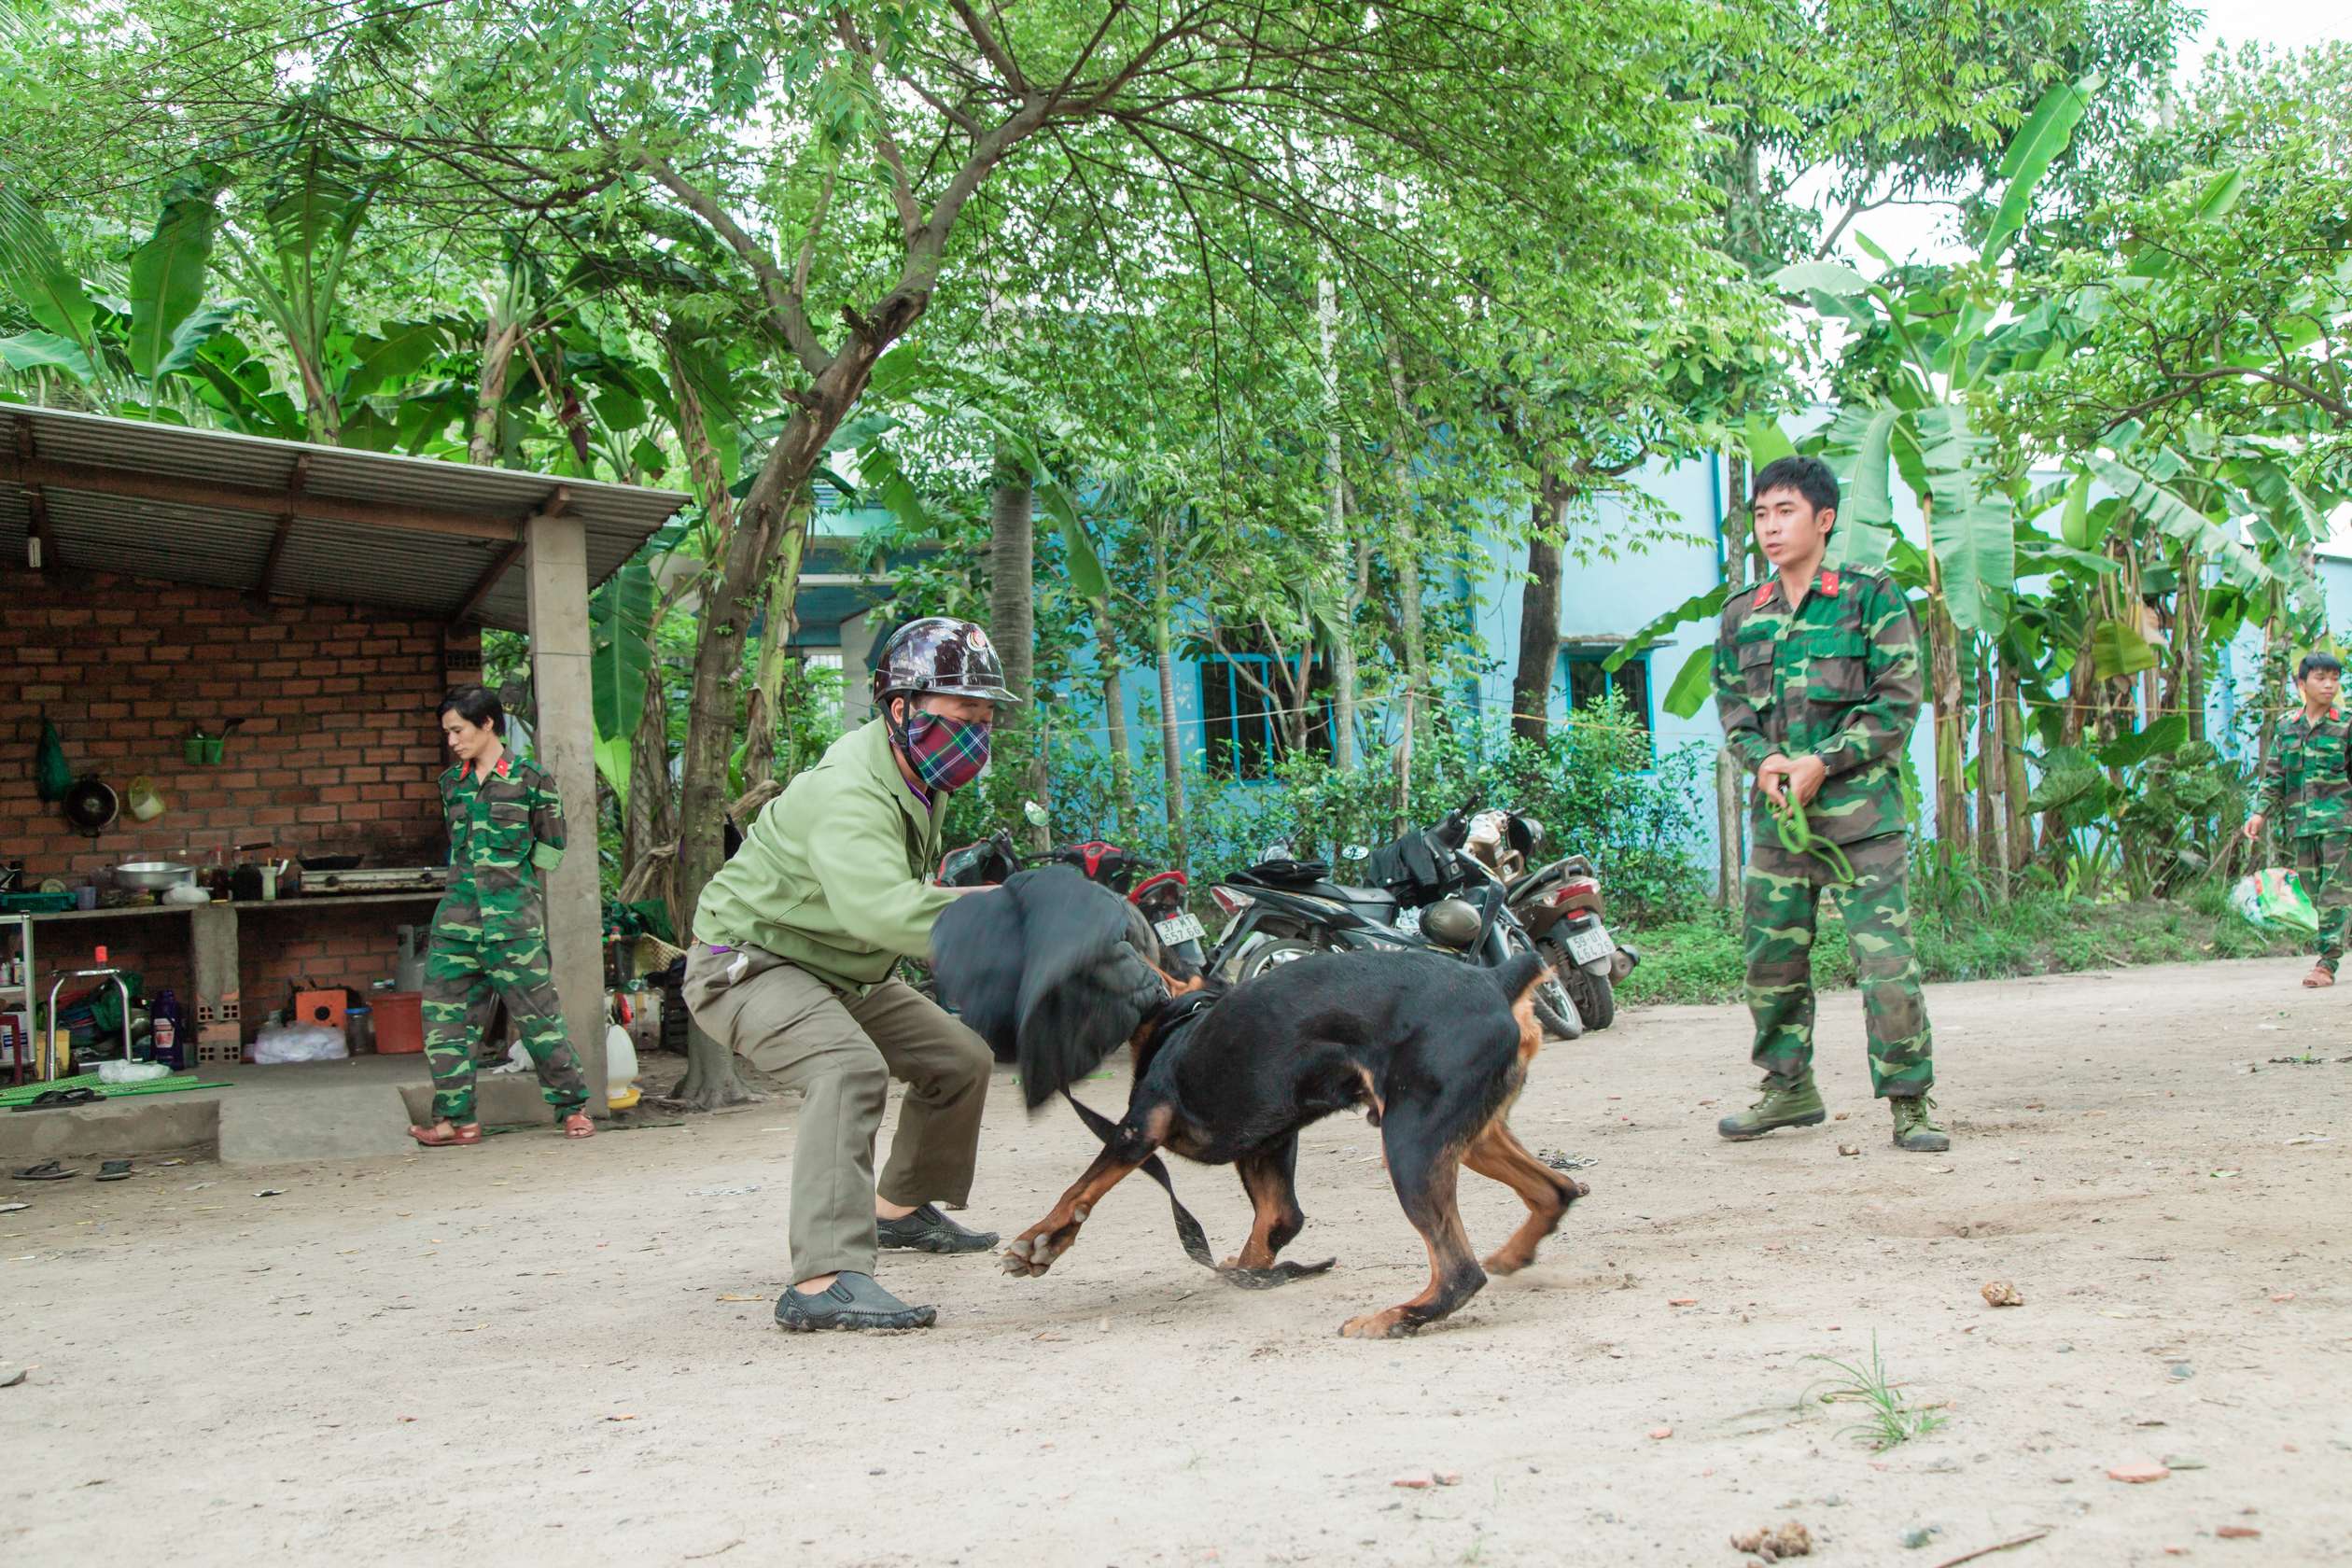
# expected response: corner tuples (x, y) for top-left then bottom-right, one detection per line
(693, 720), (955, 989)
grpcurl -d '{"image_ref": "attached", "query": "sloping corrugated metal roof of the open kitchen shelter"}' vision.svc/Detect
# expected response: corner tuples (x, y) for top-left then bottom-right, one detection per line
(0, 404), (687, 630)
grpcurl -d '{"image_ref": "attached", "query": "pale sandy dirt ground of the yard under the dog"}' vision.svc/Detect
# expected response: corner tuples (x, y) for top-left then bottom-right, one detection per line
(0, 959), (2352, 1568)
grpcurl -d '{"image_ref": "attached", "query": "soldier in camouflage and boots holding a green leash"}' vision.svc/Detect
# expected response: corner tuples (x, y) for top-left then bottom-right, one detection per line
(1715, 458), (1950, 1152)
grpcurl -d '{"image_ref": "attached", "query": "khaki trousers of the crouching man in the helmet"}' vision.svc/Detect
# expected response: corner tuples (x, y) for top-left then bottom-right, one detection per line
(684, 943), (990, 1283)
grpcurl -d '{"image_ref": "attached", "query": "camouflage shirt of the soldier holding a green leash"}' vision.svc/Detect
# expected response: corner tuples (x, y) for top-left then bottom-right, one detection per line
(1715, 567), (1919, 844)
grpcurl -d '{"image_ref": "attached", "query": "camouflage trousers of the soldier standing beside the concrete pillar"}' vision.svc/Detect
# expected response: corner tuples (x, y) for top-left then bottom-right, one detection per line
(424, 926), (588, 1126)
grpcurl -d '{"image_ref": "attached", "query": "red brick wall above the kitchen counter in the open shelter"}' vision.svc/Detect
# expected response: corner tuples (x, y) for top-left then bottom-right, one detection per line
(0, 569), (447, 884)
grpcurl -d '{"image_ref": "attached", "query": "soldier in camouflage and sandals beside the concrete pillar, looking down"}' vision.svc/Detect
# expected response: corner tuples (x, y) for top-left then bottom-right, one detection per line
(409, 686), (595, 1147)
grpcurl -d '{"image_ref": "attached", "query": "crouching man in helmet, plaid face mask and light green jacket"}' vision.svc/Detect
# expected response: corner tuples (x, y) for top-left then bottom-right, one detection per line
(684, 616), (1018, 1331)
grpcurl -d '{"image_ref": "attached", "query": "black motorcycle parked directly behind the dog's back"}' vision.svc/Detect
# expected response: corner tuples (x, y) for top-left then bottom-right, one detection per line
(1209, 806), (1583, 1039)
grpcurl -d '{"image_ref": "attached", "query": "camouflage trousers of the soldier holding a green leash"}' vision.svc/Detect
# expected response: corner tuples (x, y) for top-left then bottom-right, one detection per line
(1741, 833), (1936, 1098)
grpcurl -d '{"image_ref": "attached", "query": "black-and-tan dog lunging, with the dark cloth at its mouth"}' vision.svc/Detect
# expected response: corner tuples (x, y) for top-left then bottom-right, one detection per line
(933, 872), (1585, 1337)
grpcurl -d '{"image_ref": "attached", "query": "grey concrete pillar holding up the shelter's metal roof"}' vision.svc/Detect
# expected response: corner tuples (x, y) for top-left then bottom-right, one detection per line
(522, 515), (605, 1116)
